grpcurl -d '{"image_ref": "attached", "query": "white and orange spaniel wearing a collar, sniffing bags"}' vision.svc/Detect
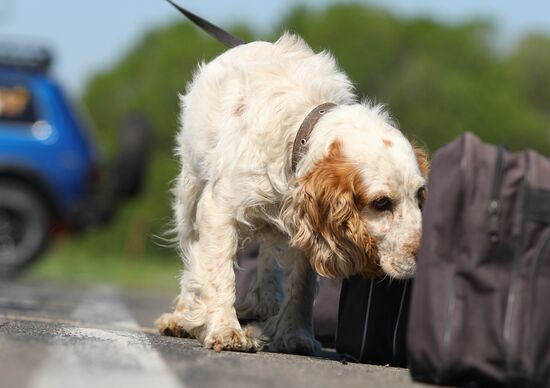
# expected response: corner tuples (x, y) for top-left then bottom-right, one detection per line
(156, 33), (429, 354)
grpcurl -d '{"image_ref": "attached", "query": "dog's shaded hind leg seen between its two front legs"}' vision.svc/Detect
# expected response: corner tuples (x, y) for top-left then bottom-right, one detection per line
(236, 232), (288, 321)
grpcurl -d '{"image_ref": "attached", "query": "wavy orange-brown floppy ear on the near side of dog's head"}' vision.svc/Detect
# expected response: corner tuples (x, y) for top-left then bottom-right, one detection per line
(283, 141), (379, 277)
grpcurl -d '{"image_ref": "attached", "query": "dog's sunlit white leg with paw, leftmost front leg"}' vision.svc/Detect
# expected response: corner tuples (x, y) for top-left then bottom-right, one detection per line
(171, 182), (258, 351)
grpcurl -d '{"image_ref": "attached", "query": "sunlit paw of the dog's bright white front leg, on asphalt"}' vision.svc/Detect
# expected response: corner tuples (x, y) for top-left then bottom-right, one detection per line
(204, 328), (261, 352)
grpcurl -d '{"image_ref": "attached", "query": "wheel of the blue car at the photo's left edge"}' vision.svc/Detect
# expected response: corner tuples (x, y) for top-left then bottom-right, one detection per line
(0, 180), (50, 277)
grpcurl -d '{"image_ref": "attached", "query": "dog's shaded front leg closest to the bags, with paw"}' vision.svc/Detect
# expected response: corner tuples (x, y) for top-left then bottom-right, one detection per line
(264, 248), (321, 355)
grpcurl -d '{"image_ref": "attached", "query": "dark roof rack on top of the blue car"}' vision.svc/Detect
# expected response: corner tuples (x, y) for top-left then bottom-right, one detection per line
(0, 41), (53, 73)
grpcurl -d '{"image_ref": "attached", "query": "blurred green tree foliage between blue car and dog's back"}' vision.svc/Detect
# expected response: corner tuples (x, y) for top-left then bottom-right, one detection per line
(83, 23), (256, 153)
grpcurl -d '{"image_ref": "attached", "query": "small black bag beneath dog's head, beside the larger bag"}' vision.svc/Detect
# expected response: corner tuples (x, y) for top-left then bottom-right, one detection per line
(336, 276), (410, 367)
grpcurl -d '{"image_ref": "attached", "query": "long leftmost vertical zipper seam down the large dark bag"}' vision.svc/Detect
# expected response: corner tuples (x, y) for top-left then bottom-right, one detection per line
(436, 135), (467, 383)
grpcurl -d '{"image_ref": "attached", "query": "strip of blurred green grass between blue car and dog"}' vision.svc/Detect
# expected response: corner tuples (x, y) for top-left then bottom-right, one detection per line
(25, 241), (182, 292)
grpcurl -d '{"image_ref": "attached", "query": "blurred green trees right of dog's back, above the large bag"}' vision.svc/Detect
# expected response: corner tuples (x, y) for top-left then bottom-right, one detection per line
(276, 5), (550, 153)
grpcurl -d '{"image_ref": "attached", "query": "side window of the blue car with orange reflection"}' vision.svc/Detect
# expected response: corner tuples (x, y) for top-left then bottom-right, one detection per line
(0, 83), (38, 125)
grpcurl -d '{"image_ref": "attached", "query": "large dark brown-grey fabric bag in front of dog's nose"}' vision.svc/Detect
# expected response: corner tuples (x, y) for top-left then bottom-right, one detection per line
(408, 134), (550, 387)
